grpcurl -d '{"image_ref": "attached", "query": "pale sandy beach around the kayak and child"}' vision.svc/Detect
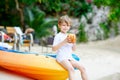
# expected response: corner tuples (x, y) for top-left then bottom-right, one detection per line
(0, 36), (120, 80)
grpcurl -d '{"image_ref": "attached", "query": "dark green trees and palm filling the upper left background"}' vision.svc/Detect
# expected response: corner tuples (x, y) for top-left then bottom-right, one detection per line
(0, 0), (91, 37)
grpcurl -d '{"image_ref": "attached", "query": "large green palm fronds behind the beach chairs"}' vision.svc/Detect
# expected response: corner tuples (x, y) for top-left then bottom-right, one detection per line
(25, 7), (57, 37)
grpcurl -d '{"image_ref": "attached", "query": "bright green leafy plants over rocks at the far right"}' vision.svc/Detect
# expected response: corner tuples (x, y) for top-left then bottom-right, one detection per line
(94, 0), (120, 37)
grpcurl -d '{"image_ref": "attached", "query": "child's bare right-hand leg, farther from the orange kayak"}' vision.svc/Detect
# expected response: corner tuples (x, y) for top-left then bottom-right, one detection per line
(70, 60), (88, 80)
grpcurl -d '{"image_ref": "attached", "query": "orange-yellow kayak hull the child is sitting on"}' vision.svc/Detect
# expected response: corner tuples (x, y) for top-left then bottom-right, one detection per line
(0, 51), (68, 80)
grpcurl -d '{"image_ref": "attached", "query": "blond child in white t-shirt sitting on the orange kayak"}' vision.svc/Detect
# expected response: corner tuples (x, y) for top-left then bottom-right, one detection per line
(52, 15), (88, 80)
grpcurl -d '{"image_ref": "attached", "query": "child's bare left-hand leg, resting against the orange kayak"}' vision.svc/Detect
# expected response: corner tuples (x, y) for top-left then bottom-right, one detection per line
(60, 60), (75, 80)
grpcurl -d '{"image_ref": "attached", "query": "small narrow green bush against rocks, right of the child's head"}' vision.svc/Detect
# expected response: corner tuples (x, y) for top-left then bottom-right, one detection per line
(78, 24), (88, 42)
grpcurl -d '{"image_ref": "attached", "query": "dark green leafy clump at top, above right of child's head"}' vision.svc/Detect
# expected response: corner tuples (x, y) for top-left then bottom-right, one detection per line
(69, 0), (92, 18)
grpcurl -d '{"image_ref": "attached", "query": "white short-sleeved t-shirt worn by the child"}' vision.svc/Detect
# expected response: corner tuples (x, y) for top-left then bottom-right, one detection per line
(53, 32), (73, 62)
